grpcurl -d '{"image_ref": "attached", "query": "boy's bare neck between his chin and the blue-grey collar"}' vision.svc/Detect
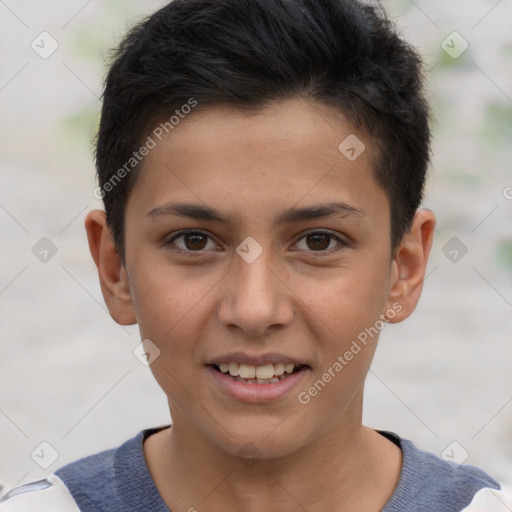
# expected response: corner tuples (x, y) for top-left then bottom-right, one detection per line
(144, 421), (401, 512)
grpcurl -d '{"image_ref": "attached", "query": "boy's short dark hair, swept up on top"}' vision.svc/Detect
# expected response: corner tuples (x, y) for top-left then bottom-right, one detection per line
(96, 0), (431, 258)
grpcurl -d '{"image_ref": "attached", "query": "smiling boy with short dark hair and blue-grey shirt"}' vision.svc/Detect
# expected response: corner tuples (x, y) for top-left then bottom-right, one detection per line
(0, 0), (510, 512)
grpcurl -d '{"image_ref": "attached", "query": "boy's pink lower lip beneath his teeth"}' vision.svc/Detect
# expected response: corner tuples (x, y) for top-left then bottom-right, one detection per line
(206, 366), (310, 403)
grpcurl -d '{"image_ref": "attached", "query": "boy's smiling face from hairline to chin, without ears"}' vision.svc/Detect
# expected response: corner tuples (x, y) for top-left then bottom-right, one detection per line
(119, 100), (396, 457)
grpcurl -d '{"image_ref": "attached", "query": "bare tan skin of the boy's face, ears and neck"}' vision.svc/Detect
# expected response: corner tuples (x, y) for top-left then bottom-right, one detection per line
(86, 99), (435, 512)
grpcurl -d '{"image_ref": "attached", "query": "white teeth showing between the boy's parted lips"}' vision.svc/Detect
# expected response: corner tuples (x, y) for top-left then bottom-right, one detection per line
(209, 362), (310, 385)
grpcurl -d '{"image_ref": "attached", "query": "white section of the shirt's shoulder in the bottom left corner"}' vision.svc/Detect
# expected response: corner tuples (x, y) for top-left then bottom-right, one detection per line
(0, 474), (80, 512)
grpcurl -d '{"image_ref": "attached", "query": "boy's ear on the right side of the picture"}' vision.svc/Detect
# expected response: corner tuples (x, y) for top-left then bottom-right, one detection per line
(384, 210), (436, 323)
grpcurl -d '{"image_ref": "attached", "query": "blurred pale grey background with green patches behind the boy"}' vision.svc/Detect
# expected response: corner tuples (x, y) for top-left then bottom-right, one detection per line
(0, 0), (512, 495)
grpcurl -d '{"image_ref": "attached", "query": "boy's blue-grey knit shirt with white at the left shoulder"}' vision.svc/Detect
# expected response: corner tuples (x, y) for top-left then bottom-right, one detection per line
(0, 427), (500, 512)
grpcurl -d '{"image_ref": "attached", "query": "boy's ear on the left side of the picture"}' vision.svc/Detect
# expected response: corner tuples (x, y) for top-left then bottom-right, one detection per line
(85, 210), (137, 325)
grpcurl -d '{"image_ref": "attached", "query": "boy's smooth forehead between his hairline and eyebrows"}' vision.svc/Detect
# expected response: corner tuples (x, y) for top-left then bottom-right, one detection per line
(128, 99), (388, 226)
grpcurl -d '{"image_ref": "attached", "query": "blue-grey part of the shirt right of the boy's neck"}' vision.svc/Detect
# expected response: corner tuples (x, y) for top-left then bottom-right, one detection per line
(384, 433), (500, 512)
